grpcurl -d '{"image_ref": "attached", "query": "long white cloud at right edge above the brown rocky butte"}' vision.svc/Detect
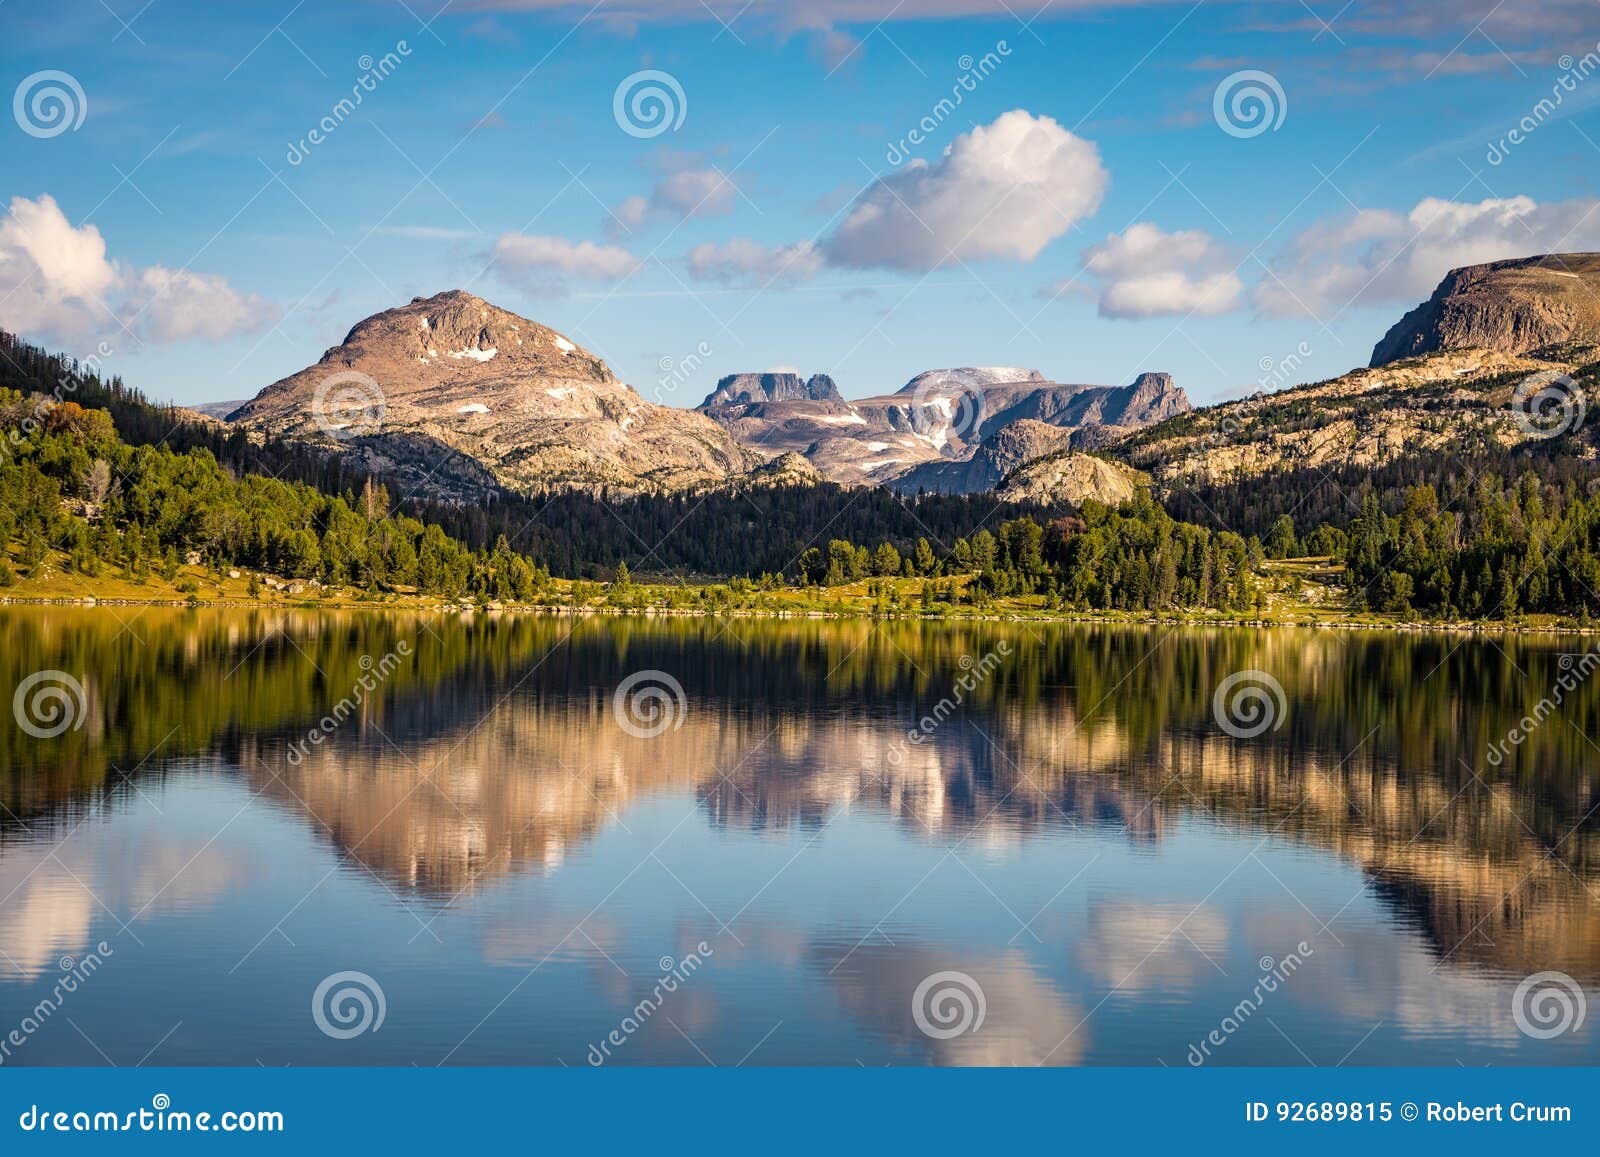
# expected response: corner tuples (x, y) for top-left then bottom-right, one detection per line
(1254, 197), (1600, 318)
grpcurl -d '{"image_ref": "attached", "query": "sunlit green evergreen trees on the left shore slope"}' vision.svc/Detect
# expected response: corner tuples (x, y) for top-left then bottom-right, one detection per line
(0, 389), (549, 599)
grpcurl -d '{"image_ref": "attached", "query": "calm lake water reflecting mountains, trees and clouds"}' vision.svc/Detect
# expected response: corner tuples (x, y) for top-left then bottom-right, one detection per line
(0, 607), (1600, 1066)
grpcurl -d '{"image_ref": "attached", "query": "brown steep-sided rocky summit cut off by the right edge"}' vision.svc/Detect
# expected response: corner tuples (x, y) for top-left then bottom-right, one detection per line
(1371, 253), (1600, 366)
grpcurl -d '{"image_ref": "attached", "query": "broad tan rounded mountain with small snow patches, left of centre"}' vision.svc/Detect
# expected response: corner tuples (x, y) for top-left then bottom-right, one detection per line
(229, 290), (762, 498)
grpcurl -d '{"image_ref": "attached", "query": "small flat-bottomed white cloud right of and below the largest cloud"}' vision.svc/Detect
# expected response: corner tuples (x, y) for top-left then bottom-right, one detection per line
(1083, 222), (1245, 317)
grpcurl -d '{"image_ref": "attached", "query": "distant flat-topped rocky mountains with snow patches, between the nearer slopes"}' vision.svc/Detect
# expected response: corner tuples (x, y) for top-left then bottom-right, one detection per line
(702, 366), (1190, 493)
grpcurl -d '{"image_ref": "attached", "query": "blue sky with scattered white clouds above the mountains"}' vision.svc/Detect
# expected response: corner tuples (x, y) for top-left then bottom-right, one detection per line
(0, 0), (1600, 405)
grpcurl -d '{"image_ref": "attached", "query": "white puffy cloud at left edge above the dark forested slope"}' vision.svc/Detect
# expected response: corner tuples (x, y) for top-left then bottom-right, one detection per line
(0, 195), (277, 342)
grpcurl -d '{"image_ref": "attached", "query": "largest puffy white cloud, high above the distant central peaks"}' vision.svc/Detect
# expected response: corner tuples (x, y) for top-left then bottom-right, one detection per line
(822, 109), (1109, 272)
